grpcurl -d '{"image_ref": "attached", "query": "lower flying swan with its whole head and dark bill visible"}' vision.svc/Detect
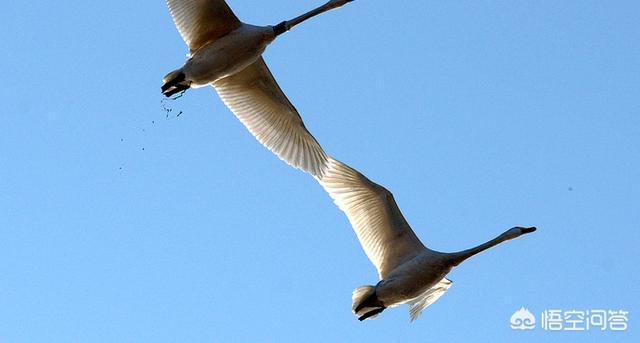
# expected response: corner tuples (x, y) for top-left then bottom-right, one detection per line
(317, 157), (536, 321)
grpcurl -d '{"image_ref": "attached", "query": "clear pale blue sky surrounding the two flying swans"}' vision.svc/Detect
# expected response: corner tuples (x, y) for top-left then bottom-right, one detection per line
(0, 0), (640, 343)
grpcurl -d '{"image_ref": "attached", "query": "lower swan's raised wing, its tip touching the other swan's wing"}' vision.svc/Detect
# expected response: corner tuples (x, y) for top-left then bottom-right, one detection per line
(318, 157), (425, 279)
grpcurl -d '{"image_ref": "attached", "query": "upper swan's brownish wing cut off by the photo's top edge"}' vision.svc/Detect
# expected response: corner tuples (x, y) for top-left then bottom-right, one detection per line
(167, 0), (240, 51)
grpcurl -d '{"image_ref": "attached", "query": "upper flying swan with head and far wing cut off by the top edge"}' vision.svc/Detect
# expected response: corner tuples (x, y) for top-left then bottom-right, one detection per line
(162, 0), (353, 176)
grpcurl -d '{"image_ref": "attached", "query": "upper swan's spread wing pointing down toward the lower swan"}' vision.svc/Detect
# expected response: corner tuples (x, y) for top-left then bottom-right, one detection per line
(213, 57), (327, 177)
